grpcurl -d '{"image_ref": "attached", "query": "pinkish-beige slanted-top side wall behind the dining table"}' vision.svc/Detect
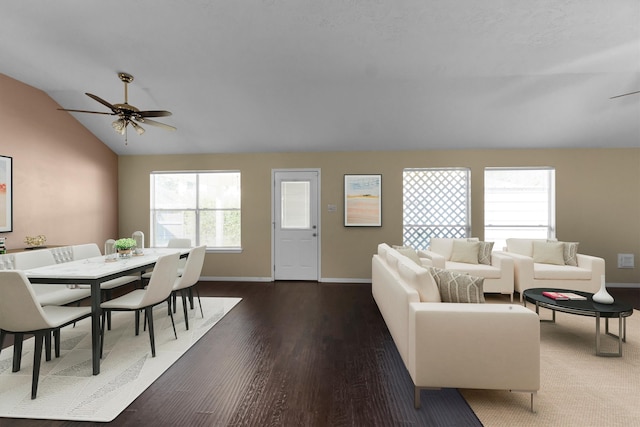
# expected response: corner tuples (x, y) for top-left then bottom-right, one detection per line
(0, 74), (118, 249)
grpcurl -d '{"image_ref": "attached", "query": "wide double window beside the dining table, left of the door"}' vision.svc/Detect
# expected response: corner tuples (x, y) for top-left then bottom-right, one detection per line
(150, 171), (241, 249)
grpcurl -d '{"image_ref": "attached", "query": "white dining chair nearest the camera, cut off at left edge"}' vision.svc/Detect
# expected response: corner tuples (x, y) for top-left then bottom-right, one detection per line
(0, 270), (91, 399)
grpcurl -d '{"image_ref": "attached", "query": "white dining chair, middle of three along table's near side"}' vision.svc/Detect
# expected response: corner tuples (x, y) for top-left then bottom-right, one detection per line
(100, 252), (180, 357)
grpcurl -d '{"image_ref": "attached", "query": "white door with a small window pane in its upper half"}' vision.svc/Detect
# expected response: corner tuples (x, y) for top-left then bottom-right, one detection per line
(273, 170), (320, 280)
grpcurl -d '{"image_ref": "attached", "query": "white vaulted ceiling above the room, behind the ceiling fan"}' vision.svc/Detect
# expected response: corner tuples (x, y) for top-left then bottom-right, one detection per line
(0, 0), (640, 154)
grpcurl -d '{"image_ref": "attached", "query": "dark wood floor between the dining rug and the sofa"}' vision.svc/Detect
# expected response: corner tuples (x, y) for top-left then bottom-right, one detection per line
(0, 282), (481, 427)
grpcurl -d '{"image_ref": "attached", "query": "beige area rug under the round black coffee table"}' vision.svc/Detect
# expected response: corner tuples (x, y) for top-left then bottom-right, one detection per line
(460, 296), (640, 427)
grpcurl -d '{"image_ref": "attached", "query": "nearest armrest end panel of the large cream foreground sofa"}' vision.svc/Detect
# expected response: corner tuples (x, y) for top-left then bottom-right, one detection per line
(408, 303), (540, 392)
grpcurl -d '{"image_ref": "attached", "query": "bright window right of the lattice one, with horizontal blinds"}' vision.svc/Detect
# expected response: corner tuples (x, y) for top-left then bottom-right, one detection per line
(484, 167), (556, 250)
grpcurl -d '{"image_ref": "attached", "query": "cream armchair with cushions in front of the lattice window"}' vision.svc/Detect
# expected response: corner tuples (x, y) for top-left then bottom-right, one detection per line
(418, 237), (514, 302)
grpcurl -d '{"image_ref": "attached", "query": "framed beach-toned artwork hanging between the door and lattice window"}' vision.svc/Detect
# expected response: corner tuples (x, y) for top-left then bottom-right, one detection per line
(344, 175), (382, 227)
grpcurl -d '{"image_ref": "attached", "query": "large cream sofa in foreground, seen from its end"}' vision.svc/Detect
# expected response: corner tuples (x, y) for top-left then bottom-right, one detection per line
(372, 243), (540, 411)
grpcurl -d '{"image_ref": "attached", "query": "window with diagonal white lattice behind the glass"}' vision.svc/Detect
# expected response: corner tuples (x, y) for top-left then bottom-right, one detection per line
(402, 168), (471, 249)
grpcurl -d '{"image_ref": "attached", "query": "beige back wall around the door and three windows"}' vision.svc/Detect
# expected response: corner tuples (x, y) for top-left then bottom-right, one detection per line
(119, 149), (640, 283)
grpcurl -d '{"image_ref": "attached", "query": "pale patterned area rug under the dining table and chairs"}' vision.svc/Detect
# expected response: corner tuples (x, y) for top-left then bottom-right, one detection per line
(0, 298), (240, 424)
